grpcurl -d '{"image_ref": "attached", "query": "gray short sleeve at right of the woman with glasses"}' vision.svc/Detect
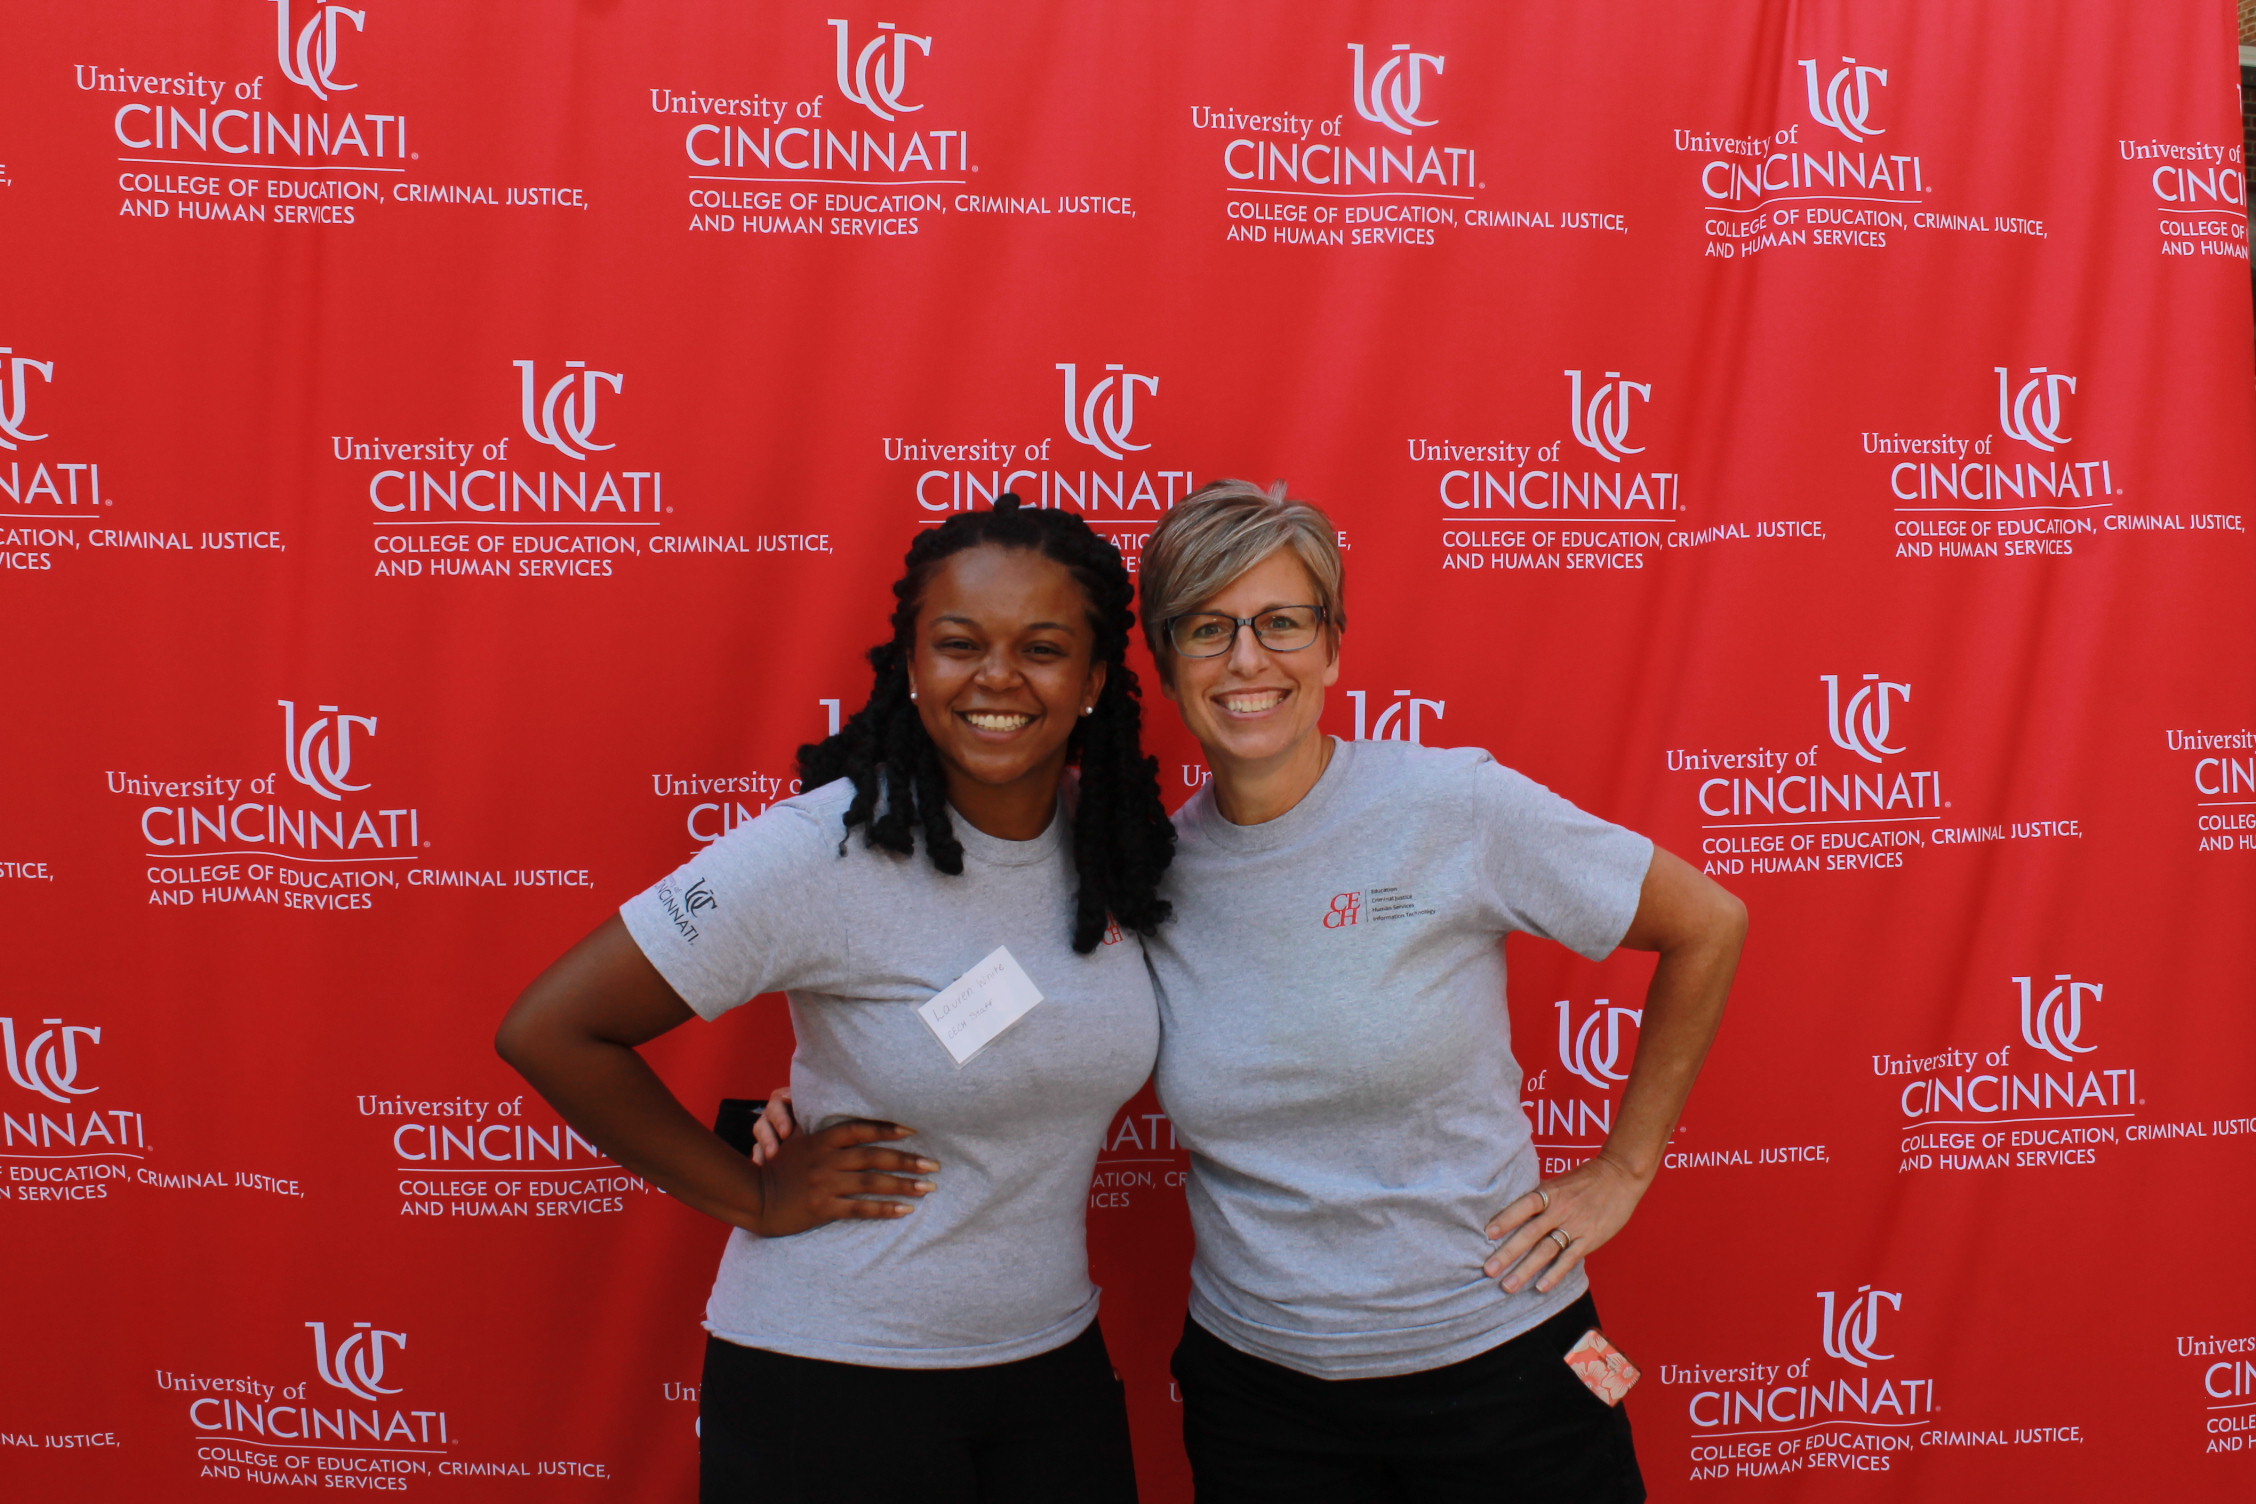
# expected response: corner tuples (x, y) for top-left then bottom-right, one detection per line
(1471, 758), (1654, 961)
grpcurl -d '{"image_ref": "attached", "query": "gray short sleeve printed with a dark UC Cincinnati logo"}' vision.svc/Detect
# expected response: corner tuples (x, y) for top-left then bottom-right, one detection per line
(618, 796), (846, 1019)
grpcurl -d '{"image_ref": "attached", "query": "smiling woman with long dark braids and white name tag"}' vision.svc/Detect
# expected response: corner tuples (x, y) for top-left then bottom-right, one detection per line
(496, 496), (1173, 1504)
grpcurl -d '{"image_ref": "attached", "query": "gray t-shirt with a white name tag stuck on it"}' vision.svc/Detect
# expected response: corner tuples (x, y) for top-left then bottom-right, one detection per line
(620, 780), (1160, 1369)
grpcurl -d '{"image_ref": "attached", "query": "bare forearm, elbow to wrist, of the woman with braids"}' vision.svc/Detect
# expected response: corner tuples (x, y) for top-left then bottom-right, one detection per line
(510, 1039), (760, 1229)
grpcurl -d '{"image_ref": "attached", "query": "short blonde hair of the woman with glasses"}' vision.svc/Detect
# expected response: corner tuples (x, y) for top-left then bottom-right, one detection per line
(1137, 480), (1347, 681)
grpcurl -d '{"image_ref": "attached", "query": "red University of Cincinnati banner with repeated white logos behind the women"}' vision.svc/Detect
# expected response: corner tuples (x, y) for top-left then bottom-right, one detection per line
(0, 0), (2256, 1504)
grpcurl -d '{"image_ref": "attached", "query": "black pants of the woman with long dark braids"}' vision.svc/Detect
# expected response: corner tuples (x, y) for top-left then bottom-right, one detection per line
(697, 1321), (1135, 1504)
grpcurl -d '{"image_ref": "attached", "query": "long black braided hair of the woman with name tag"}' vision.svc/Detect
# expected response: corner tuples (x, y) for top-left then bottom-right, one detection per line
(799, 492), (1175, 954)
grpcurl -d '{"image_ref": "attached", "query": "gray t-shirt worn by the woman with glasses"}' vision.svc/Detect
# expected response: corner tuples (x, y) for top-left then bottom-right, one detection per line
(1146, 742), (1654, 1378)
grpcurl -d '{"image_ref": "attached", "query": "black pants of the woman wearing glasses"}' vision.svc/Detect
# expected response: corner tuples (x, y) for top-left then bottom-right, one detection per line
(1175, 1297), (1645, 1504)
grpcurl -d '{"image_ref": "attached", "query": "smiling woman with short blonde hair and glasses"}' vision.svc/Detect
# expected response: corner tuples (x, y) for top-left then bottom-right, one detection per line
(1142, 480), (1746, 1504)
